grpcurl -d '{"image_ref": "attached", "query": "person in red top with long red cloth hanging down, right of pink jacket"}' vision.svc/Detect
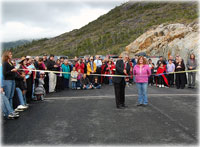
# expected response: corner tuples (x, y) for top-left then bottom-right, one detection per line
(156, 62), (169, 88)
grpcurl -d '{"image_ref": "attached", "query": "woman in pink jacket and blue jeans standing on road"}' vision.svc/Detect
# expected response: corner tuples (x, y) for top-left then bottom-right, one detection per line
(133, 56), (151, 106)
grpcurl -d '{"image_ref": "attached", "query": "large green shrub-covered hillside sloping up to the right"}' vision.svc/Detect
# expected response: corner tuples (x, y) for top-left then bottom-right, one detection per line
(12, 2), (198, 57)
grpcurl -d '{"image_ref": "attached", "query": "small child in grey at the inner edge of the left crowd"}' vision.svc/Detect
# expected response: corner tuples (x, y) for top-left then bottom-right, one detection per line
(35, 72), (45, 101)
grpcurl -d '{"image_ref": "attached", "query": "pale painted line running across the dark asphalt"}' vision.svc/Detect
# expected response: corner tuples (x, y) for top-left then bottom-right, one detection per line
(45, 93), (200, 100)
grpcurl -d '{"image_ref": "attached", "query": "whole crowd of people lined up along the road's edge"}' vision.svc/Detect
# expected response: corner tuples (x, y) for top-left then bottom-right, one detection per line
(0, 51), (197, 119)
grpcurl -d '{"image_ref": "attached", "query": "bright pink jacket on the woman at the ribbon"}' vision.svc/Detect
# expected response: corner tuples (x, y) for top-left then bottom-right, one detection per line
(133, 64), (151, 83)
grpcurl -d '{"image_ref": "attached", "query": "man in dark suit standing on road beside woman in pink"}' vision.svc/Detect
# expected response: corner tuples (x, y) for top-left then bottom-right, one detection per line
(113, 55), (130, 109)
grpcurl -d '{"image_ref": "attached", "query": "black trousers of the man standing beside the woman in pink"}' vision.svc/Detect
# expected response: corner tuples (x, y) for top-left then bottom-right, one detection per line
(114, 80), (125, 107)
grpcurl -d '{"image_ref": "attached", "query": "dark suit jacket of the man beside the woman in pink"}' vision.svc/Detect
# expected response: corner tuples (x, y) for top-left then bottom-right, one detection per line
(113, 60), (130, 83)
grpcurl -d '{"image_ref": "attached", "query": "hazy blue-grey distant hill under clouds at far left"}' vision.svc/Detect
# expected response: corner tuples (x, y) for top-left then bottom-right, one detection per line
(2, 40), (31, 50)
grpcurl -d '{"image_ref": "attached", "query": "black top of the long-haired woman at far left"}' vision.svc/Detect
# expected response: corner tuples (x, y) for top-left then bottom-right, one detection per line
(3, 62), (16, 80)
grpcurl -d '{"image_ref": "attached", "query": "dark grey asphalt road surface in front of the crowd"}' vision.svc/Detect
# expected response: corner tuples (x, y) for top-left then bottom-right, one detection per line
(2, 85), (198, 145)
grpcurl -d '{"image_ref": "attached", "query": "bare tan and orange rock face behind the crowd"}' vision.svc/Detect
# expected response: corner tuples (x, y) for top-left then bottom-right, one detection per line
(122, 21), (199, 60)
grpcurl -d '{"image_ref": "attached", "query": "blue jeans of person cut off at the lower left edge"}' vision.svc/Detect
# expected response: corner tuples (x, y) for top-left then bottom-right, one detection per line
(1, 94), (14, 117)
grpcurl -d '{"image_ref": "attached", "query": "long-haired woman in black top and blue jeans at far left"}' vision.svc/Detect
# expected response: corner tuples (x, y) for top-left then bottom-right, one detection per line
(2, 51), (17, 108)
